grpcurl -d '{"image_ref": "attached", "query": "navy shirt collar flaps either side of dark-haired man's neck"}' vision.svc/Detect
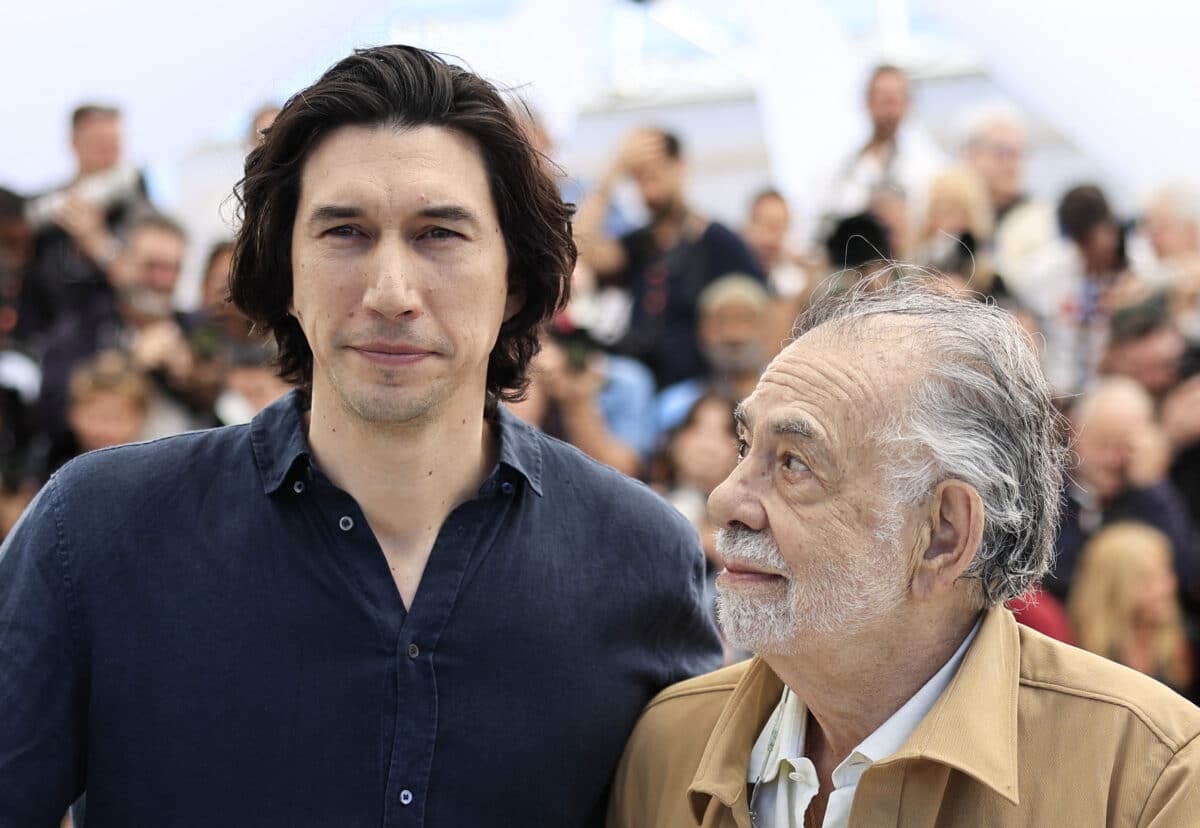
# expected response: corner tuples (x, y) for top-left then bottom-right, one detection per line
(250, 390), (542, 496)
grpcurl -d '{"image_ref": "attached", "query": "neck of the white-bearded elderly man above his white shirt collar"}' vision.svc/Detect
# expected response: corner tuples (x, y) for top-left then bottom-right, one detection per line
(766, 600), (978, 770)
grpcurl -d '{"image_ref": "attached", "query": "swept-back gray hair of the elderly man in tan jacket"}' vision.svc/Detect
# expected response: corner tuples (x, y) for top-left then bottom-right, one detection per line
(796, 273), (1068, 606)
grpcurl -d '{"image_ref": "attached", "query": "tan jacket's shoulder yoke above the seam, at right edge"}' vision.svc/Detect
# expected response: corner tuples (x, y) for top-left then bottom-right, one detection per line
(1020, 625), (1200, 754)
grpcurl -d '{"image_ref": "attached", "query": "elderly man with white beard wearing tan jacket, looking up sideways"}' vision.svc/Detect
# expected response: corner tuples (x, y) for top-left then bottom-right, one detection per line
(608, 277), (1200, 828)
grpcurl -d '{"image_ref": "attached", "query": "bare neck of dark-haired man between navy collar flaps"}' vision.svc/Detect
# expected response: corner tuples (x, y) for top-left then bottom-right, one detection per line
(308, 388), (497, 551)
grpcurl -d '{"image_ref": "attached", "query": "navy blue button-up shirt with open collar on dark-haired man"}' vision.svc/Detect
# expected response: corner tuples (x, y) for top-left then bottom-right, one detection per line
(0, 395), (720, 828)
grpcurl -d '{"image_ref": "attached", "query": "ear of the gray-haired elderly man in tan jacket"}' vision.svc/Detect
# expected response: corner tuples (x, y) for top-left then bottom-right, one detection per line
(912, 480), (983, 600)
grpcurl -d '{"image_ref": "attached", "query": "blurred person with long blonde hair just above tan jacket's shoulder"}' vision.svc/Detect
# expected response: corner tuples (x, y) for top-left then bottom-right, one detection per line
(1068, 521), (1195, 700)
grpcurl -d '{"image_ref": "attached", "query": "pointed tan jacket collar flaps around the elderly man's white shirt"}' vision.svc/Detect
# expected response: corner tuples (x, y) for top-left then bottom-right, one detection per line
(688, 606), (1020, 822)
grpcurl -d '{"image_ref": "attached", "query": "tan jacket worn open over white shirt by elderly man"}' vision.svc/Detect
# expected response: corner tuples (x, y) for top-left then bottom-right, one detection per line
(608, 608), (1200, 828)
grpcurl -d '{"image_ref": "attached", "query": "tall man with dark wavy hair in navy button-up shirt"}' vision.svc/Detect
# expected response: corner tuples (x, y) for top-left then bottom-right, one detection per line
(0, 46), (720, 828)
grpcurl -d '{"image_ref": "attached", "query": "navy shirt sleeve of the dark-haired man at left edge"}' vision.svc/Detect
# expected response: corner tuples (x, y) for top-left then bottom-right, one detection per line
(0, 479), (86, 828)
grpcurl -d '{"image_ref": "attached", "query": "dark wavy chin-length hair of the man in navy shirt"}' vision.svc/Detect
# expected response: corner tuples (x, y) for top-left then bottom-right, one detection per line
(229, 46), (576, 401)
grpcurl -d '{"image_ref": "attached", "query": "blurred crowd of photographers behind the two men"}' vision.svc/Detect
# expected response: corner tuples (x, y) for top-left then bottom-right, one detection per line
(0, 66), (1200, 700)
